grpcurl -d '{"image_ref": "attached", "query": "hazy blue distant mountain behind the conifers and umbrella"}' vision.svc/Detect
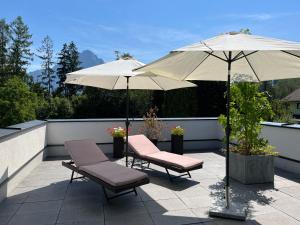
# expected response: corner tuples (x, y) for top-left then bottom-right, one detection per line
(29, 50), (104, 88)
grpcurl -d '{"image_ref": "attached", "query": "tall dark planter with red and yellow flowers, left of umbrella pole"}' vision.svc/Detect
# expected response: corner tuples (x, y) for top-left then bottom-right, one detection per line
(107, 127), (126, 158)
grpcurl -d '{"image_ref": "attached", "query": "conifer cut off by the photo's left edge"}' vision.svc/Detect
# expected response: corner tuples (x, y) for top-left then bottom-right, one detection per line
(0, 19), (10, 80)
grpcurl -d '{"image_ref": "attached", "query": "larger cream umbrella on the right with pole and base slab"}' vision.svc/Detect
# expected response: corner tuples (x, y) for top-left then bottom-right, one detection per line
(136, 32), (300, 219)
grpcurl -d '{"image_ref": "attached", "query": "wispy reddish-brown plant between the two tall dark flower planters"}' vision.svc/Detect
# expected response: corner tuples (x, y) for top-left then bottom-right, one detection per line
(141, 106), (164, 145)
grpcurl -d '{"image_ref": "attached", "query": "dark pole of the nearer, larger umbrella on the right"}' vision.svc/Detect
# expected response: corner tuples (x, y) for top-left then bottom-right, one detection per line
(225, 51), (231, 208)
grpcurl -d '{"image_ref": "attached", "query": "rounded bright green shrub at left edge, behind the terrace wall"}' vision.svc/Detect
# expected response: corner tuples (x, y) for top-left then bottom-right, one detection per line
(0, 77), (37, 127)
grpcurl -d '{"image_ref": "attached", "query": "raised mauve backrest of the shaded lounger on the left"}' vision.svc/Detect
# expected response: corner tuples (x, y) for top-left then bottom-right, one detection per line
(65, 139), (108, 167)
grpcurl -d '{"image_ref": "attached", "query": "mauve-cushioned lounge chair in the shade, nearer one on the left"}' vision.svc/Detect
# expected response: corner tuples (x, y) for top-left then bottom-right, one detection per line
(62, 139), (149, 201)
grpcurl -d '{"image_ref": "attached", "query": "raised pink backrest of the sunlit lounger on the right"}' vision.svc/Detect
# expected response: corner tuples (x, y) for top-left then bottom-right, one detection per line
(128, 134), (160, 156)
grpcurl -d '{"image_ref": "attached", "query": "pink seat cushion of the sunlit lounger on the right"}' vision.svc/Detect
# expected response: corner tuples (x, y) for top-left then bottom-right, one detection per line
(145, 151), (203, 170)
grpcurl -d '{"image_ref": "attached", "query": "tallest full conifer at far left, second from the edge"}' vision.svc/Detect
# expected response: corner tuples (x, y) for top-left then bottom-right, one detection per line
(9, 16), (33, 77)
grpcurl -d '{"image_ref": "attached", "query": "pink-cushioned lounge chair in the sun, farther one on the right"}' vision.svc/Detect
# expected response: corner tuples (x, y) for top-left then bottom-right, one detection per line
(128, 135), (203, 181)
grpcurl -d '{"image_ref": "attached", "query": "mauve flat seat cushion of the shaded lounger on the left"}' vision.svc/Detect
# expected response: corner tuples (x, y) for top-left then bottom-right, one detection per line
(80, 161), (148, 187)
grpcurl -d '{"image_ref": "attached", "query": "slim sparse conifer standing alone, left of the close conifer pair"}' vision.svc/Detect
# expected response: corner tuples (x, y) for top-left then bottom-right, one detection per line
(37, 35), (55, 96)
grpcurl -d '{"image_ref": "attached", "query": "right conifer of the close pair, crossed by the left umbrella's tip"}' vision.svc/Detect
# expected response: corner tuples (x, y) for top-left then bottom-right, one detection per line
(67, 41), (81, 97)
